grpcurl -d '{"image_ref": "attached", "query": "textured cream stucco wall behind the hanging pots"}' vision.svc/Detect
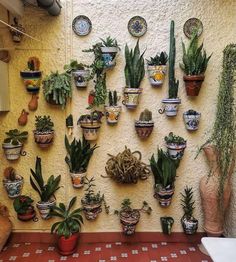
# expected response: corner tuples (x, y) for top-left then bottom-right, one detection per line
(0, 0), (236, 232)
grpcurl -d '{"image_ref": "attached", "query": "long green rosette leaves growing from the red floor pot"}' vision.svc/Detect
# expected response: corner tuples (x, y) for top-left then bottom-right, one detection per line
(49, 197), (83, 238)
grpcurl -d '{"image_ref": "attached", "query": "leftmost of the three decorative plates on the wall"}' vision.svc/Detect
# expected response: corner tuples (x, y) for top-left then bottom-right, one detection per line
(72, 15), (92, 36)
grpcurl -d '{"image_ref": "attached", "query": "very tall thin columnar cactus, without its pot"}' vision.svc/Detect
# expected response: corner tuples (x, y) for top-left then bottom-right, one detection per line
(169, 20), (179, 98)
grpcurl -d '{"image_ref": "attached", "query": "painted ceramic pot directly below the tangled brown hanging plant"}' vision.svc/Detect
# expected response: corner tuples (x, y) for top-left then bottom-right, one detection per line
(120, 210), (140, 235)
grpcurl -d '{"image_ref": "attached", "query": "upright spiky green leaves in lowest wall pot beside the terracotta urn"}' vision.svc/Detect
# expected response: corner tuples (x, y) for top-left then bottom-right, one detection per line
(181, 186), (195, 220)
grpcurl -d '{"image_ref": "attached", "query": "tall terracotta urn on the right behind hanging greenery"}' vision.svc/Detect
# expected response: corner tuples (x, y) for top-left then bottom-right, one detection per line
(200, 145), (235, 236)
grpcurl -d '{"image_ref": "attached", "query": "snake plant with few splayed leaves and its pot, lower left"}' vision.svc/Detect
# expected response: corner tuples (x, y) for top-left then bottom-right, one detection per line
(30, 157), (61, 219)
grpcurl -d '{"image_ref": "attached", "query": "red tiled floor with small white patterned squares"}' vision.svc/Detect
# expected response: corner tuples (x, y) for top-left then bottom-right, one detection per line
(0, 242), (212, 262)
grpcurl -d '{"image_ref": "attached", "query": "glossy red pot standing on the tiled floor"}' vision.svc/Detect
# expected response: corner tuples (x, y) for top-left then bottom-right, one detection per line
(57, 234), (79, 256)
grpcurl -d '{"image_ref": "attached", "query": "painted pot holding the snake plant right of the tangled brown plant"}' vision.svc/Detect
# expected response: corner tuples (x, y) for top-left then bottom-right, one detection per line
(154, 186), (175, 207)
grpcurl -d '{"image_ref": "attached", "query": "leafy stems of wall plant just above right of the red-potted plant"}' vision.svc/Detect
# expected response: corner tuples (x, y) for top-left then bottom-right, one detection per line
(81, 177), (110, 214)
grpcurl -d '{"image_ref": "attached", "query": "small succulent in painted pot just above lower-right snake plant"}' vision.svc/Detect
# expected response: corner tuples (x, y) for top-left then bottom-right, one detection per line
(165, 132), (187, 160)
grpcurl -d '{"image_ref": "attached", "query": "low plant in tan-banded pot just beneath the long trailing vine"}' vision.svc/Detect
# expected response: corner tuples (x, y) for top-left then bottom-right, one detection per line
(77, 111), (103, 141)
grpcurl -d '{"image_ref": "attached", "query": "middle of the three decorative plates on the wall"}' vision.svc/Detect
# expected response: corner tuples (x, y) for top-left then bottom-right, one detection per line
(128, 16), (147, 37)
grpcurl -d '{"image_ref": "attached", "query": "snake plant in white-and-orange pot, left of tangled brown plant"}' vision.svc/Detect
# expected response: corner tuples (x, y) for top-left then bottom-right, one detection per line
(65, 136), (97, 188)
